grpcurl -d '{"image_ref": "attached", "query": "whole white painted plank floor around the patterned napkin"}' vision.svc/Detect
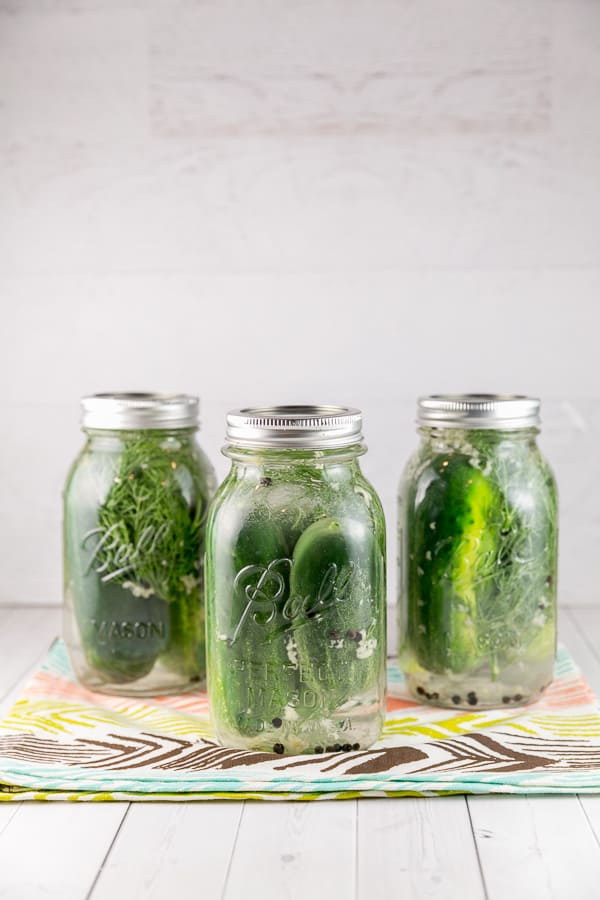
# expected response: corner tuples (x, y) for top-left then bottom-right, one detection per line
(0, 607), (600, 900)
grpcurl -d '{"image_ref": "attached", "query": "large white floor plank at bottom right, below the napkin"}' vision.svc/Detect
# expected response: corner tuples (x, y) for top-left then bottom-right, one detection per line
(468, 796), (600, 900)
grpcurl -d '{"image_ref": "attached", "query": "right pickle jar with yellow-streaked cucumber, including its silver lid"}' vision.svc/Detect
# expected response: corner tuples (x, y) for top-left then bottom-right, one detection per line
(399, 394), (557, 709)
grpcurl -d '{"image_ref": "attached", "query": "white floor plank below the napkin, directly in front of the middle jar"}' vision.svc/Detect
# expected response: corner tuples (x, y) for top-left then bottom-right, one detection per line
(223, 800), (357, 900)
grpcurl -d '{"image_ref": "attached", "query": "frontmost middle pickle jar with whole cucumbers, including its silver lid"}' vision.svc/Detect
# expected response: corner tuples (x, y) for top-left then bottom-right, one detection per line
(206, 406), (386, 753)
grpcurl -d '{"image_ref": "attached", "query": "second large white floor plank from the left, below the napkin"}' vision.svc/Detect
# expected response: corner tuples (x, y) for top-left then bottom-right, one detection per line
(90, 802), (243, 900)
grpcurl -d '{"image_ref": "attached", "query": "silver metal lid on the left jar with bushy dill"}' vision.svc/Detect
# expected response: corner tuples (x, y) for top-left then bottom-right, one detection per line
(81, 394), (200, 431)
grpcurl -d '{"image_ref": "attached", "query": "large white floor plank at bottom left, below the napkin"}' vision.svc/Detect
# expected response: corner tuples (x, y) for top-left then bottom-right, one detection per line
(0, 802), (128, 900)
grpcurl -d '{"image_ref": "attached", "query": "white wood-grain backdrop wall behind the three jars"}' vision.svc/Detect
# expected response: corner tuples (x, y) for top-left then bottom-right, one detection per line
(0, 0), (600, 604)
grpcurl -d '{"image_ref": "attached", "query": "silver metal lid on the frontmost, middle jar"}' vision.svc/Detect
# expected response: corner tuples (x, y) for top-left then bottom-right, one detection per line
(225, 406), (362, 450)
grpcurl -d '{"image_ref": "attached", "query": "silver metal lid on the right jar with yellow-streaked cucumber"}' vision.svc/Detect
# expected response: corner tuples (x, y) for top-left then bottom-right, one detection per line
(417, 394), (540, 430)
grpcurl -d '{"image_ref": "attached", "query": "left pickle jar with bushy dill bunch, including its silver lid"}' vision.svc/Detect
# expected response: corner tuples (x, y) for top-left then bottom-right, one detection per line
(64, 394), (215, 695)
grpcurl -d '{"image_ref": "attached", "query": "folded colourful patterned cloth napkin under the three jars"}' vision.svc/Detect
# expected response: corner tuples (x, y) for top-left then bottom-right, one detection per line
(0, 641), (600, 801)
